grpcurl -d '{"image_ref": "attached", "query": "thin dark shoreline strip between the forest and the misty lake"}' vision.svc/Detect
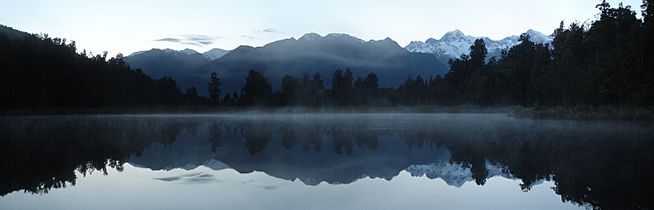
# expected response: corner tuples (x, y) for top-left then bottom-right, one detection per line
(0, 105), (654, 121)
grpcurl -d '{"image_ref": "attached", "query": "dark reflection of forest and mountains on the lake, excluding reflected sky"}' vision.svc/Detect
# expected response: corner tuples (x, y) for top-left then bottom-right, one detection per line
(0, 114), (654, 209)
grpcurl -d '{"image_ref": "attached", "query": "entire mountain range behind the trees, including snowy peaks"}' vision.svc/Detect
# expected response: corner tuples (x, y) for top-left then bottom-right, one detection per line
(125, 30), (552, 93)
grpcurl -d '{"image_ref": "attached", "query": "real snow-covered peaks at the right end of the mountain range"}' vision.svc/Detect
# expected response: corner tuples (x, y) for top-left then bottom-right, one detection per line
(405, 29), (553, 61)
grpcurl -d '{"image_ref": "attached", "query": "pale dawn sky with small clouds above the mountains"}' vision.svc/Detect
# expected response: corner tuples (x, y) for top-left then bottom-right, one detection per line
(0, 0), (642, 55)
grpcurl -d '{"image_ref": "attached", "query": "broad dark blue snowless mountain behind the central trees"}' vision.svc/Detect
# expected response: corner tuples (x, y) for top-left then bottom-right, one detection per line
(197, 34), (447, 91)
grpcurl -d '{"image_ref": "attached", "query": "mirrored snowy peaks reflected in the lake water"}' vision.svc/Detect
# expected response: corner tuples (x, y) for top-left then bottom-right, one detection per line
(406, 161), (515, 187)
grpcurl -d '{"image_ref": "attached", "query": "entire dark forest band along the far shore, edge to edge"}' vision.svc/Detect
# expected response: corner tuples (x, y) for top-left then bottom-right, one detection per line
(0, 0), (654, 109)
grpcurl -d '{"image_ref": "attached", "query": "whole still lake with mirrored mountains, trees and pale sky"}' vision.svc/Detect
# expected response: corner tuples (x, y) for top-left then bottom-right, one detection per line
(0, 114), (654, 209)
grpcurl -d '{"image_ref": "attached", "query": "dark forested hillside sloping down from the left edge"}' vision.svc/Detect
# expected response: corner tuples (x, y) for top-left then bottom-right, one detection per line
(0, 27), (201, 109)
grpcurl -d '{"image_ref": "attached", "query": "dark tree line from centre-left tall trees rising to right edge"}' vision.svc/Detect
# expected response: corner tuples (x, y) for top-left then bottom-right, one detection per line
(209, 0), (654, 106)
